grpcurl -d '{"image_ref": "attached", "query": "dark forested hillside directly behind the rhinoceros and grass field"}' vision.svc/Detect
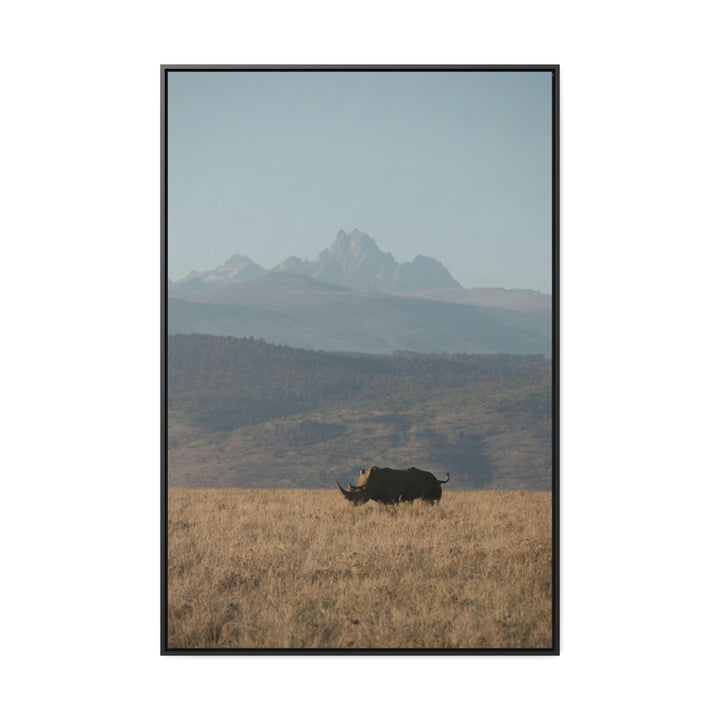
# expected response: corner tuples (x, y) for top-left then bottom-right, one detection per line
(168, 335), (551, 490)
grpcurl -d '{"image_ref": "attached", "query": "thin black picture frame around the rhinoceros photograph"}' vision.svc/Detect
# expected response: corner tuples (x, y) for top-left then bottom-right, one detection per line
(160, 64), (560, 656)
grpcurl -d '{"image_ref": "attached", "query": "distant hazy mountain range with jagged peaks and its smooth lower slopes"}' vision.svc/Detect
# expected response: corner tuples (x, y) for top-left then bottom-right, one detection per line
(168, 230), (552, 356)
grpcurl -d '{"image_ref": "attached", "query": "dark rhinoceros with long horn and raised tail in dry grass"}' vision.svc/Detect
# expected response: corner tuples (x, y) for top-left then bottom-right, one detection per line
(335, 465), (450, 505)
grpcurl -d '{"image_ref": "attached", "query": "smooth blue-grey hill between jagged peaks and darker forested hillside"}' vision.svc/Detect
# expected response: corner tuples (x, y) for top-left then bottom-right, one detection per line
(168, 272), (551, 355)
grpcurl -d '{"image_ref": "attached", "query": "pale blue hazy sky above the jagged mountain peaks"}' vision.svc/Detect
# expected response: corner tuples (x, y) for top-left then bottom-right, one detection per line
(168, 71), (552, 292)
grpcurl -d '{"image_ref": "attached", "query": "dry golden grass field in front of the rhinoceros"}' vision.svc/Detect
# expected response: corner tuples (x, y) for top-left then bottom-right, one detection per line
(167, 488), (552, 649)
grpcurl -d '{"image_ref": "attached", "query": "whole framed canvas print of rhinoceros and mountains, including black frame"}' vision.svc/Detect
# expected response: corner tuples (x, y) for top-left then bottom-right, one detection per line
(161, 65), (559, 655)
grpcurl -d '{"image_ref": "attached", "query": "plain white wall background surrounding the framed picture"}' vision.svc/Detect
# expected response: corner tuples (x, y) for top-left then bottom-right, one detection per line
(0, 0), (720, 720)
